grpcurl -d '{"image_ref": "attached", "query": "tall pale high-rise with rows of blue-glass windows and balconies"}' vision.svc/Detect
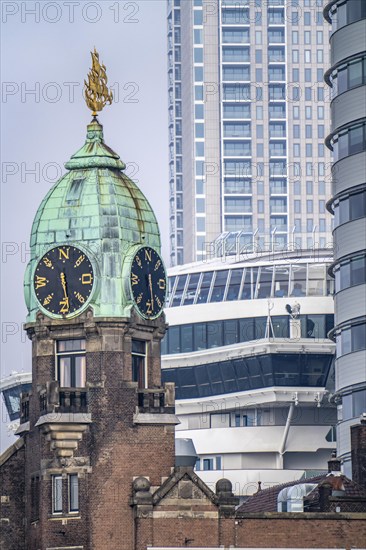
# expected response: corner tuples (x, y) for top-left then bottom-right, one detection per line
(168, 0), (331, 265)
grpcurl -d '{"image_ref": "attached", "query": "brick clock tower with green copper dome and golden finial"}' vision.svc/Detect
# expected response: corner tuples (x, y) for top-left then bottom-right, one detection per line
(17, 51), (178, 550)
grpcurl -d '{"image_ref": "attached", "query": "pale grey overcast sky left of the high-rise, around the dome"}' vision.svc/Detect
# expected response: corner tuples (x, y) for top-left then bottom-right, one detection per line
(1, 0), (168, 447)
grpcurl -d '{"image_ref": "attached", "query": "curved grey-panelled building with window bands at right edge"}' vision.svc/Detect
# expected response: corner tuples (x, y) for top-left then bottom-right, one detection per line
(324, 0), (366, 477)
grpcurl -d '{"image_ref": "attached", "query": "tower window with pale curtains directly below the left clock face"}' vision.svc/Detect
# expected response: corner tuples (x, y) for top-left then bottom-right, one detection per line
(57, 340), (86, 388)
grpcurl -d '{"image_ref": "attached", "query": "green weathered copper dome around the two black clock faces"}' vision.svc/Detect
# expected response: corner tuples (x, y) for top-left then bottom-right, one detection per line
(24, 119), (160, 322)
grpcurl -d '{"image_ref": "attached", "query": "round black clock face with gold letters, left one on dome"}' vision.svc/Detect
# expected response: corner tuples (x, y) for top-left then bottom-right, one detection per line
(33, 246), (94, 316)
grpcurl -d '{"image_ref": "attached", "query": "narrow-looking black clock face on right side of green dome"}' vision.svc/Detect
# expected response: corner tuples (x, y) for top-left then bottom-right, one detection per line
(130, 246), (166, 319)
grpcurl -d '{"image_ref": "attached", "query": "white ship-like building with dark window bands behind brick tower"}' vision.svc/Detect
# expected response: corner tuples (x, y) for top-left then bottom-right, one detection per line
(162, 250), (336, 495)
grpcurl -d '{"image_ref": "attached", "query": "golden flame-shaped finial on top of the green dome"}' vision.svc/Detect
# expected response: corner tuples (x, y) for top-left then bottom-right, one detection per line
(84, 47), (113, 117)
